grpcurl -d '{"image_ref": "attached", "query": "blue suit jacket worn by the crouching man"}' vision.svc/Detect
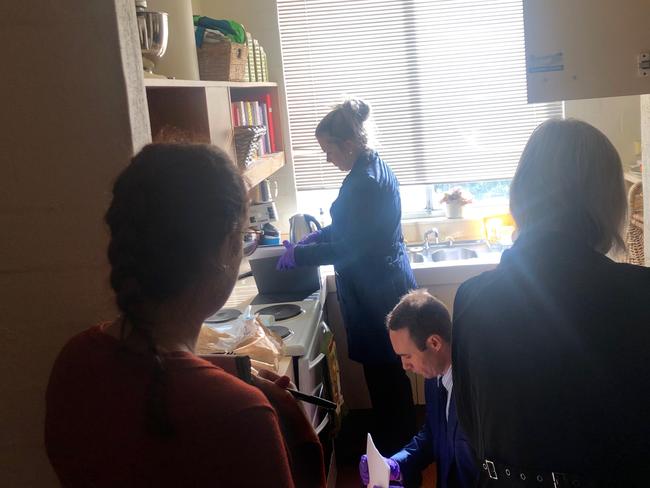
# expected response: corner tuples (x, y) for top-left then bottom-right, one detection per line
(391, 378), (479, 488)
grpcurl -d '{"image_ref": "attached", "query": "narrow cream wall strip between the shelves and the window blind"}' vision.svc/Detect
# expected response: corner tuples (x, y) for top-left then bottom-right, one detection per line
(192, 0), (296, 232)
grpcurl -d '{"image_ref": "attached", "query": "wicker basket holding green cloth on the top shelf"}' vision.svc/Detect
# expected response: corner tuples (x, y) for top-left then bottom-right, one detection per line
(196, 40), (248, 81)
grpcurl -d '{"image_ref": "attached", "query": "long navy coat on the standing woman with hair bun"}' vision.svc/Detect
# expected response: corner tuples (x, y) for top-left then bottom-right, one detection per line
(295, 151), (416, 364)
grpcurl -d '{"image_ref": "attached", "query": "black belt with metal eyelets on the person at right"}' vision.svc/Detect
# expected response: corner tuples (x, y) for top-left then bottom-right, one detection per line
(481, 459), (598, 488)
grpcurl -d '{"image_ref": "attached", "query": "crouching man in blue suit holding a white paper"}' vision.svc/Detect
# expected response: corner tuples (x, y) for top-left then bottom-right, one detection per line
(359, 290), (478, 488)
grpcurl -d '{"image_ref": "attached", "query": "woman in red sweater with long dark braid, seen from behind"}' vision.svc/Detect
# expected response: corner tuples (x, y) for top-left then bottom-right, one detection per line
(45, 144), (324, 487)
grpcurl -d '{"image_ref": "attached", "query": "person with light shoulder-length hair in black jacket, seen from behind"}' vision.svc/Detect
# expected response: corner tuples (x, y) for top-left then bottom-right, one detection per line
(452, 120), (650, 488)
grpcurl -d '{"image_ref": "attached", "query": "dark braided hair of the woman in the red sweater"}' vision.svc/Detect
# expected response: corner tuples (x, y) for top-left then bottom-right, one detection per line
(106, 144), (247, 437)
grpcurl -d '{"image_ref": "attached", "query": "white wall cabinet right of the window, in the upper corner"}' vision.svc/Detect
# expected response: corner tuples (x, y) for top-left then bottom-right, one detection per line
(524, 0), (650, 103)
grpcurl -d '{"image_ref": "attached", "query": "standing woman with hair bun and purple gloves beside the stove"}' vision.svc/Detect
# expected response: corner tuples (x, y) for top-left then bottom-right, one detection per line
(278, 99), (416, 455)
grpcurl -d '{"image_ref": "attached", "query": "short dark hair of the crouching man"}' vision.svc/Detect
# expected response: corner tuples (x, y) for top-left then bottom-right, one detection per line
(386, 290), (451, 351)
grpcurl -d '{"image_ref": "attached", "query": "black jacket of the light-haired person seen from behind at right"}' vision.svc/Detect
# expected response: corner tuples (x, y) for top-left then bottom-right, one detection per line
(453, 232), (650, 486)
